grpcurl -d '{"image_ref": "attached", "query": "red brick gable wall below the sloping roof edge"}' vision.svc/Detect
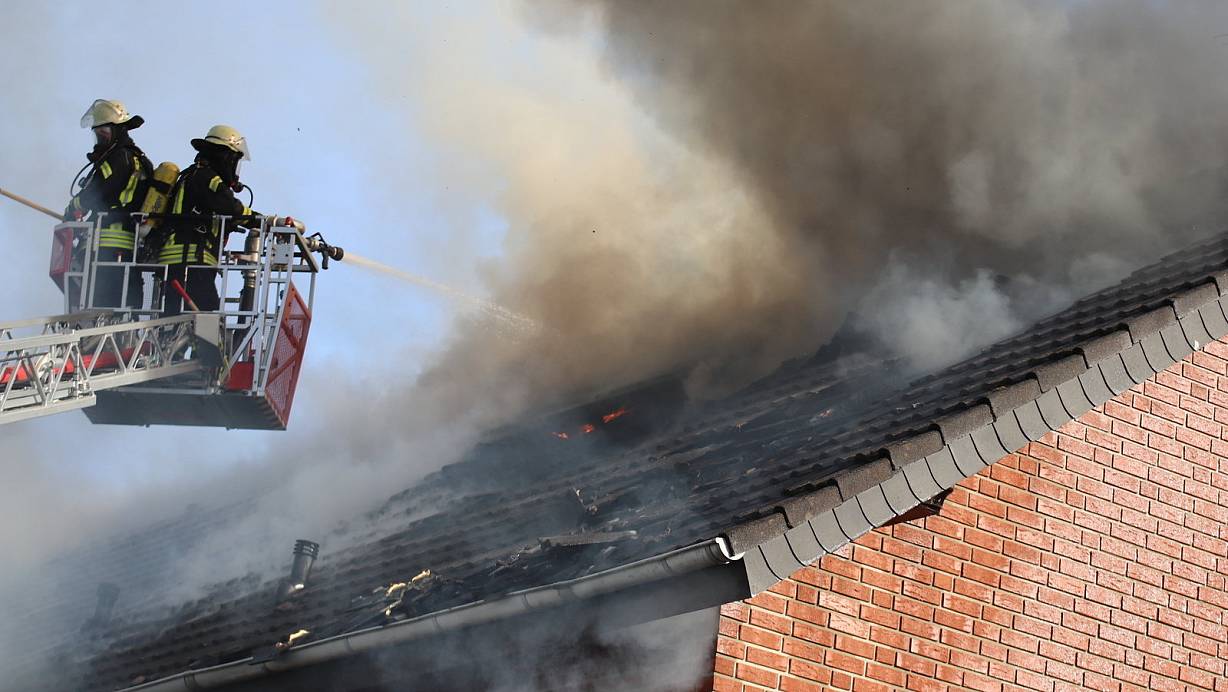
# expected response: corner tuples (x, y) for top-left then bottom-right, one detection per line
(713, 342), (1228, 692)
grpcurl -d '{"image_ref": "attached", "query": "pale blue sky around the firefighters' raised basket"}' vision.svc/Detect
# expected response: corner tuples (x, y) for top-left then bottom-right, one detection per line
(0, 1), (518, 498)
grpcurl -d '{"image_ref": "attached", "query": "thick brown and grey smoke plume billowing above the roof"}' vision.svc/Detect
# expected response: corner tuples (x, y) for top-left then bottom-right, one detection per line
(383, 0), (1228, 382)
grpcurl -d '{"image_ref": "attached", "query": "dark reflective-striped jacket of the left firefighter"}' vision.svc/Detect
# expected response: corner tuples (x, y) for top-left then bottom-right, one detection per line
(68, 134), (154, 252)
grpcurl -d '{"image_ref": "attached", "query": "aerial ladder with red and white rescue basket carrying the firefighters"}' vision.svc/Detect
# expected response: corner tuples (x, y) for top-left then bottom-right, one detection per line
(0, 215), (344, 431)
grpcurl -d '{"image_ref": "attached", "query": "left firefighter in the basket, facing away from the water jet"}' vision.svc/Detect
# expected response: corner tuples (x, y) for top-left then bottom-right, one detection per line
(64, 98), (154, 308)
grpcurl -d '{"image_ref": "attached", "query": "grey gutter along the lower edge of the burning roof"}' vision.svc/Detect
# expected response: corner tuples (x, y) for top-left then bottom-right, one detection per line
(120, 536), (742, 692)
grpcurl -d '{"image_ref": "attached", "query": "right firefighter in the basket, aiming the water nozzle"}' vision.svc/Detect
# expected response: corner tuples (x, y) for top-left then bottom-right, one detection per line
(157, 125), (254, 315)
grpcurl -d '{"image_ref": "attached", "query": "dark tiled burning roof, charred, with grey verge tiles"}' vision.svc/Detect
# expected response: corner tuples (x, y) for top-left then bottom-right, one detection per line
(11, 229), (1228, 690)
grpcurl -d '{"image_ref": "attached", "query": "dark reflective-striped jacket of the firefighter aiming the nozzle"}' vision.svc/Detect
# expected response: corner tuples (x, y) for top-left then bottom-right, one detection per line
(157, 156), (254, 265)
